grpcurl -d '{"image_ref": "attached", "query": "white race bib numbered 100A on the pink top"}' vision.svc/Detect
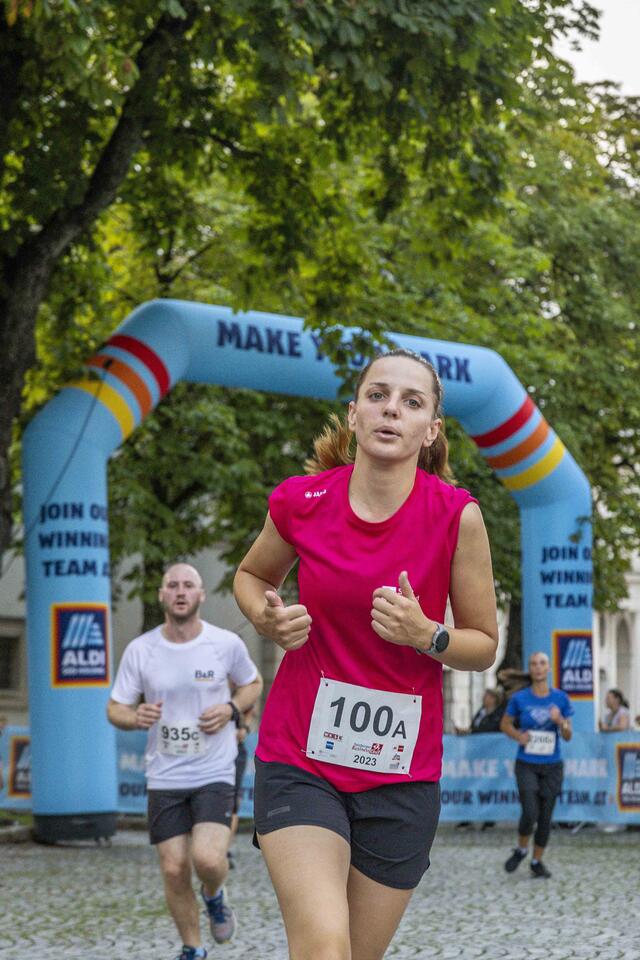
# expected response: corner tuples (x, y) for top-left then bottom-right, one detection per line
(306, 677), (422, 774)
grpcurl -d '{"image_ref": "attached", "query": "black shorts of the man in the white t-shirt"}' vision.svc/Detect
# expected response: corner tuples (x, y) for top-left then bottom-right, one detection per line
(147, 783), (235, 843)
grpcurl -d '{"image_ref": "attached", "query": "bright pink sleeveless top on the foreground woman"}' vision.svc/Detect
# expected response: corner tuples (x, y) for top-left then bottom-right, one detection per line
(256, 466), (476, 792)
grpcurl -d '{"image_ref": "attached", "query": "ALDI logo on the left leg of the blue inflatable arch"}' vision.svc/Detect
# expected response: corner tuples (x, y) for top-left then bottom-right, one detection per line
(51, 603), (110, 687)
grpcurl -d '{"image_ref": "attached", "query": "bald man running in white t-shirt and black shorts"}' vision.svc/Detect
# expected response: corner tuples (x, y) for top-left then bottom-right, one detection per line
(107, 563), (262, 960)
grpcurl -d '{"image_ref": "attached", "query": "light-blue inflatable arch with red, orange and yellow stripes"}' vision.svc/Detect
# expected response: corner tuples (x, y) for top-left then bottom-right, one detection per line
(23, 300), (593, 841)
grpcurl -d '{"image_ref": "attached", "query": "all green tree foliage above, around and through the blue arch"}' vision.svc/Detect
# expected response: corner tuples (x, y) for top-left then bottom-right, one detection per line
(5, 0), (640, 628)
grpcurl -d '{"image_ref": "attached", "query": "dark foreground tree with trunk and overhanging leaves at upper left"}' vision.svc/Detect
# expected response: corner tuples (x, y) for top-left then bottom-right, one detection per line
(0, 0), (595, 554)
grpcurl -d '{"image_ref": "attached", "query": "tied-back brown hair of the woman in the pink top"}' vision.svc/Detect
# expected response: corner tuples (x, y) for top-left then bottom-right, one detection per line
(304, 348), (454, 483)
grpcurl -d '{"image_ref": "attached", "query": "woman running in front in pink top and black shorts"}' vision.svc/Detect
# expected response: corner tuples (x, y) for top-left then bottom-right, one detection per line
(235, 350), (497, 960)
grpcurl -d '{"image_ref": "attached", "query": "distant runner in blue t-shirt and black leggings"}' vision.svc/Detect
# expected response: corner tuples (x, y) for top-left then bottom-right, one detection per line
(500, 653), (573, 878)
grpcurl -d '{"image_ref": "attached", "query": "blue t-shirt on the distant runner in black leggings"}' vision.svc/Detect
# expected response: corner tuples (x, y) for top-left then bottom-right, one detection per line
(506, 687), (574, 763)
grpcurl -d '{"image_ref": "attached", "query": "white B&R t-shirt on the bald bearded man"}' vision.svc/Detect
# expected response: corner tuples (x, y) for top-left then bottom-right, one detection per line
(111, 621), (258, 790)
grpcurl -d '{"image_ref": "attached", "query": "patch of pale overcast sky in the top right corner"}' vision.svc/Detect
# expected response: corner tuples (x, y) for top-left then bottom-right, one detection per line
(557, 0), (640, 96)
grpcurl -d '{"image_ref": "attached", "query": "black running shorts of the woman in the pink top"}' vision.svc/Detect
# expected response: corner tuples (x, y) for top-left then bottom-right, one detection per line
(254, 757), (440, 890)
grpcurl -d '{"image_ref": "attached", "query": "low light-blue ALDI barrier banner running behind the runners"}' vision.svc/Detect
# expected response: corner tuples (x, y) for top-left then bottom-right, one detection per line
(0, 727), (640, 824)
